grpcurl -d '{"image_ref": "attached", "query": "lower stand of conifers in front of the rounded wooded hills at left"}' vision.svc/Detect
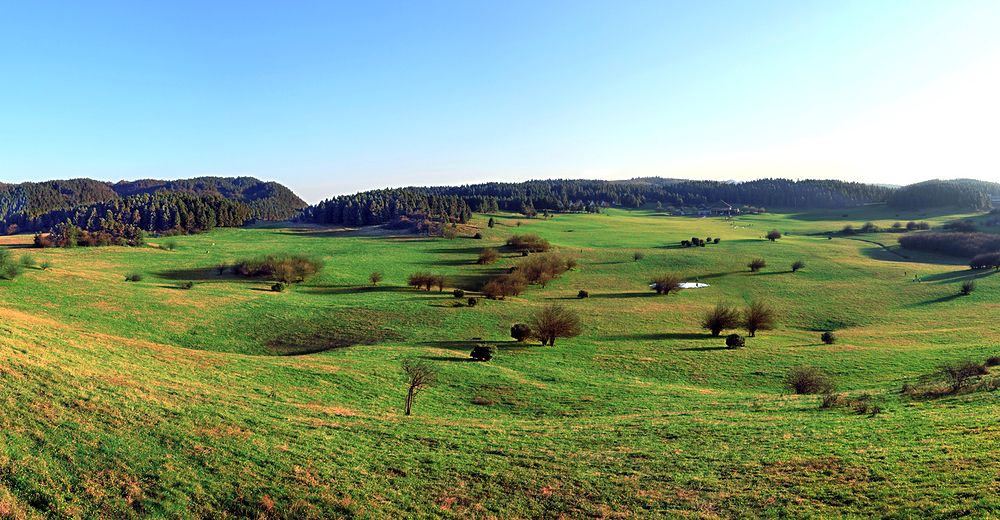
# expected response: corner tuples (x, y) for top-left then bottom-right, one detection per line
(25, 193), (251, 247)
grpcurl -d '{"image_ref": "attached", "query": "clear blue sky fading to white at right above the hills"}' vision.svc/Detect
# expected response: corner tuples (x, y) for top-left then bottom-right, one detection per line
(0, 0), (1000, 201)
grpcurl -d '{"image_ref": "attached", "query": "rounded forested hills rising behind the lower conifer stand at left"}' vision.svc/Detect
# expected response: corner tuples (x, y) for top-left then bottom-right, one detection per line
(0, 177), (307, 231)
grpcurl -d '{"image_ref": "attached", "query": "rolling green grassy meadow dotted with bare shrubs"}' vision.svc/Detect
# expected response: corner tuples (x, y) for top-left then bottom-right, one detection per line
(0, 208), (1000, 518)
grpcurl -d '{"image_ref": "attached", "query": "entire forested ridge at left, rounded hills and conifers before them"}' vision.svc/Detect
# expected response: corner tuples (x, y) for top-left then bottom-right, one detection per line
(0, 177), (306, 233)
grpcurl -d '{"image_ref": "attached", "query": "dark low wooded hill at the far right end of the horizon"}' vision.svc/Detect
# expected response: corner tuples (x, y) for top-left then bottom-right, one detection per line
(886, 179), (1000, 211)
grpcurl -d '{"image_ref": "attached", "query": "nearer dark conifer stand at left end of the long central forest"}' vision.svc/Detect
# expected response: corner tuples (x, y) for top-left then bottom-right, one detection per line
(299, 189), (473, 226)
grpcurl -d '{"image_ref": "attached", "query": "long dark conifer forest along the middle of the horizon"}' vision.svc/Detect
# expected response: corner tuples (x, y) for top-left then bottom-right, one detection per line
(301, 178), (891, 226)
